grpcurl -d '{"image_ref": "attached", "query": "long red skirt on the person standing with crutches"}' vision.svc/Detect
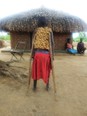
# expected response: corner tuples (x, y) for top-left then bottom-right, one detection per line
(32, 52), (51, 83)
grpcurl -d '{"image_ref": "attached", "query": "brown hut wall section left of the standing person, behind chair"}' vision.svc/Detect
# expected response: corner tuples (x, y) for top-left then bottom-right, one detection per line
(10, 32), (32, 50)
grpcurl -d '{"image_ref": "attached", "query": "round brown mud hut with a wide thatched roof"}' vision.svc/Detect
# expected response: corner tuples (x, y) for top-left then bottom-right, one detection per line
(0, 8), (87, 50)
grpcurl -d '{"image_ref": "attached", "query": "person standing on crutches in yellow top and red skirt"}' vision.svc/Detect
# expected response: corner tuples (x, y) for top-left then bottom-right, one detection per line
(32, 17), (54, 90)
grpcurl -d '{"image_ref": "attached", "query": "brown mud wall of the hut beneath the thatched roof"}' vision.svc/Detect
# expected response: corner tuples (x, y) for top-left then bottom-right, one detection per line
(10, 32), (72, 50)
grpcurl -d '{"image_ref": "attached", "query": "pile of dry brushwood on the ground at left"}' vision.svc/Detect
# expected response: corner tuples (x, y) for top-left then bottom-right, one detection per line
(0, 60), (27, 82)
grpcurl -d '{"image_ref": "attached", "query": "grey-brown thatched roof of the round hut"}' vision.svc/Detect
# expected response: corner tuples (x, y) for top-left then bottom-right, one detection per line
(0, 8), (87, 32)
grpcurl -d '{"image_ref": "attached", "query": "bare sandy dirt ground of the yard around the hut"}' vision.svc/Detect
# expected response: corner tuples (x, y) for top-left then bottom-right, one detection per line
(0, 52), (87, 116)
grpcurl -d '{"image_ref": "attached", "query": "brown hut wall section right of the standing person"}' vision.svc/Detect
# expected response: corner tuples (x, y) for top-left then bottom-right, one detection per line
(54, 32), (72, 50)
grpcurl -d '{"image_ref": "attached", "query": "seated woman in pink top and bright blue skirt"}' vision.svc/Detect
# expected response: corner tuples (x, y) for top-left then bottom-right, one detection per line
(66, 38), (77, 54)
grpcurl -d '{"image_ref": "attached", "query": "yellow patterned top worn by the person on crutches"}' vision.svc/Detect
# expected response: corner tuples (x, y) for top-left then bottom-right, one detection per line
(34, 27), (52, 50)
